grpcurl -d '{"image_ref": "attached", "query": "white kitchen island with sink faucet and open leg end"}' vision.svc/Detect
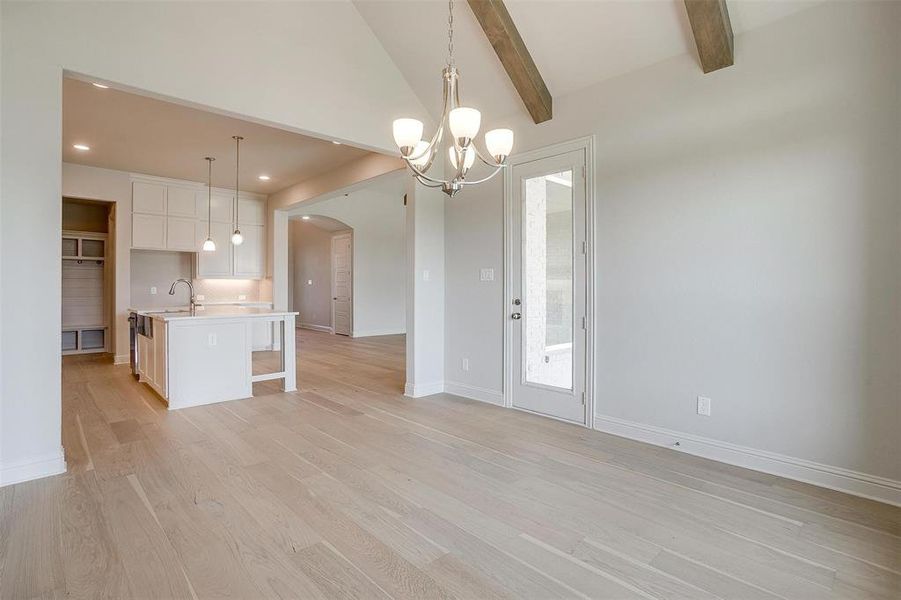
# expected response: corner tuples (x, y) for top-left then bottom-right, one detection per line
(134, 306), (297, 410)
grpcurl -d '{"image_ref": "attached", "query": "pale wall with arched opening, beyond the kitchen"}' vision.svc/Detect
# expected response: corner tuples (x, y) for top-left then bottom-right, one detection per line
(294, 188), (406, 337)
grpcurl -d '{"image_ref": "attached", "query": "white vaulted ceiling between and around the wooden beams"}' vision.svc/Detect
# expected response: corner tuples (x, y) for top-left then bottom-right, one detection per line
(354, 0), (822, 123)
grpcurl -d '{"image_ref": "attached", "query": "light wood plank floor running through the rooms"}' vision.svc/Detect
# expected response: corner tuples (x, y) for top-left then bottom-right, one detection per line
(0, 331), (901, 600)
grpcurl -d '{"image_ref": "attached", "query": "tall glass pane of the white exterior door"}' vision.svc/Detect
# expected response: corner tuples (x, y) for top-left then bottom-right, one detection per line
(522, 171), (573, 389)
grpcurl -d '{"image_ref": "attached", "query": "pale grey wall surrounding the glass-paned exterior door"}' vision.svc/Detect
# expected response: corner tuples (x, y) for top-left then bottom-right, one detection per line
(445, 2), (901, 488)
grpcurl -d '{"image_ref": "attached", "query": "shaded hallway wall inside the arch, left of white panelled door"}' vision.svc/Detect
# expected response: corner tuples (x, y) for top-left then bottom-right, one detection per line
(289, 220), (335, 328)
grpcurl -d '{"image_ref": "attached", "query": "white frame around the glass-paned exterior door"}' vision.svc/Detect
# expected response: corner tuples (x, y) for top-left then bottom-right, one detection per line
(501, 135), (596, 428)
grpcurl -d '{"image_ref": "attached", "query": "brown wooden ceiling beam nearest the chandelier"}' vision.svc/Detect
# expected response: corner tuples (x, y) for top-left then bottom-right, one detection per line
(468, 0), (553, 123)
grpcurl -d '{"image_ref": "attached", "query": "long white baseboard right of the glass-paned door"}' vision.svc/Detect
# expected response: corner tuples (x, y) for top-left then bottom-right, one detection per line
(594, 416), (901, 506)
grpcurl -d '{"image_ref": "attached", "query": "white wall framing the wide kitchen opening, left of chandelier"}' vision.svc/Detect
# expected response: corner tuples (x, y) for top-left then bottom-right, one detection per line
(0, 2), (427, 483)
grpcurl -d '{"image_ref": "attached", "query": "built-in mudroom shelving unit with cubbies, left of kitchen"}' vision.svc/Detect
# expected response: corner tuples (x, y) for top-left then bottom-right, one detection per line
(62, 231), (109, 354)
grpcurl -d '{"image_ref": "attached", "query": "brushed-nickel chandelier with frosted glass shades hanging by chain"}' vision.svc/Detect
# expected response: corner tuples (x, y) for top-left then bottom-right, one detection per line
(393, 0), (513, 196)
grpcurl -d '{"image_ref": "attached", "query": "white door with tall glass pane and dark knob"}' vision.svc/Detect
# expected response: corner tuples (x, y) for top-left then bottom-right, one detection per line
(507, 150), (587, 423)
